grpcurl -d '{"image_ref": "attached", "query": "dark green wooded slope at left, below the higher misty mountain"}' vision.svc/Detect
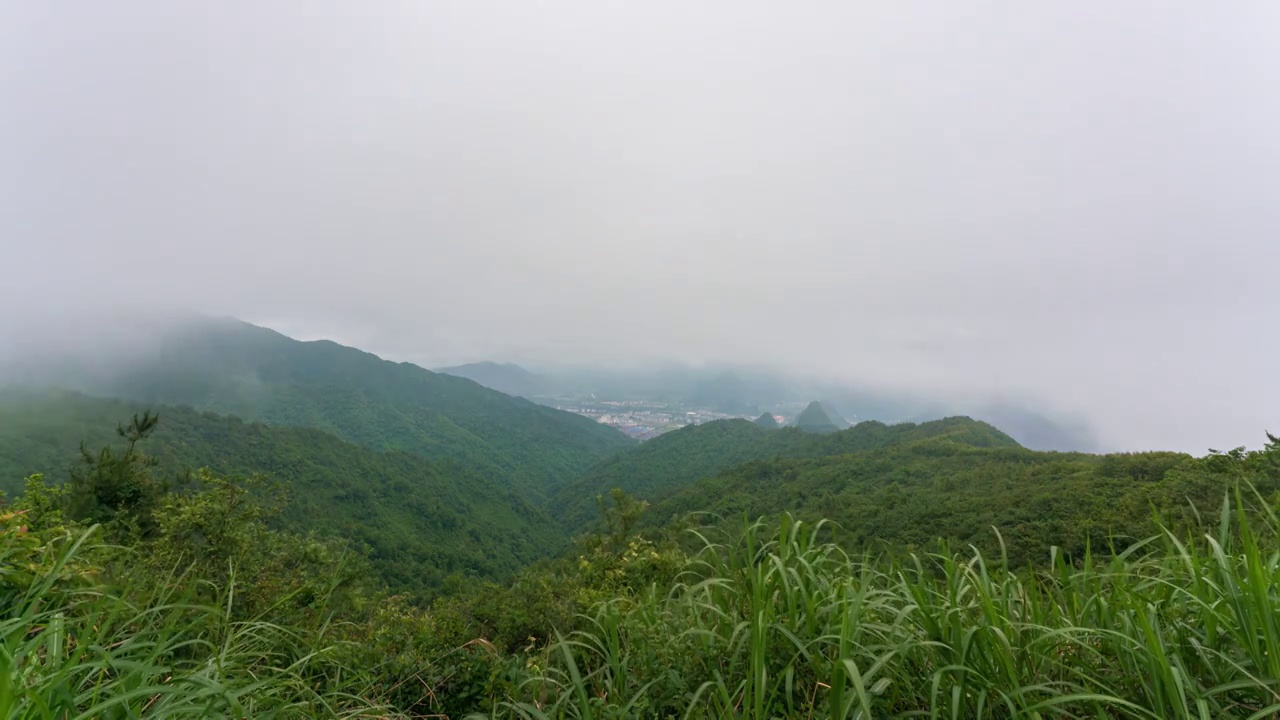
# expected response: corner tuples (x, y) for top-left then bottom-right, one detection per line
(0, 392), (559, 592)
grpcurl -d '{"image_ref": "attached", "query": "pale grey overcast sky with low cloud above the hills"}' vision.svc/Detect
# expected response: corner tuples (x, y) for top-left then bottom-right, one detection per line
(0, 0), (1280, 451)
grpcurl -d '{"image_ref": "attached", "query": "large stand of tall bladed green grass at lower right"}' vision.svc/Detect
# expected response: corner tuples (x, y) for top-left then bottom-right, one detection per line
(495, 495), (1280, 720)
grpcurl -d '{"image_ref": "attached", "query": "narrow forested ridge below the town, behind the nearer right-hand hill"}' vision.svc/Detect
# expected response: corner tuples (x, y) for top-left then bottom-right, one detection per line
(548, 418), (1018, 529)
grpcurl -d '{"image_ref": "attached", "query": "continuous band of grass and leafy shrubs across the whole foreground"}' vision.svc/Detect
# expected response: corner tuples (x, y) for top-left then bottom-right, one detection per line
(10, 466), (1280, 720)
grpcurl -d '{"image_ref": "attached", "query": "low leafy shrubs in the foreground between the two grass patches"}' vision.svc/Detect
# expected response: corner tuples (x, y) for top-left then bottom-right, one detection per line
(311, 486), (687, 717)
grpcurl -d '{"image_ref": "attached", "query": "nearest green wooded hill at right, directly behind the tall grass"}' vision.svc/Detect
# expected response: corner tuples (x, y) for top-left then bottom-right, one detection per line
(649, 435), (1233, 564)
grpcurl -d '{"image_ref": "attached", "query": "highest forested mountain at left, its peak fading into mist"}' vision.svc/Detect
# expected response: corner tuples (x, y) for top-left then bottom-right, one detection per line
(8, 318), (631, 496)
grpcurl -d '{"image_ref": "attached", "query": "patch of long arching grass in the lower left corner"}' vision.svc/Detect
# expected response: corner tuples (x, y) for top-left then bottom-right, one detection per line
(0, 523), (394, 720)
